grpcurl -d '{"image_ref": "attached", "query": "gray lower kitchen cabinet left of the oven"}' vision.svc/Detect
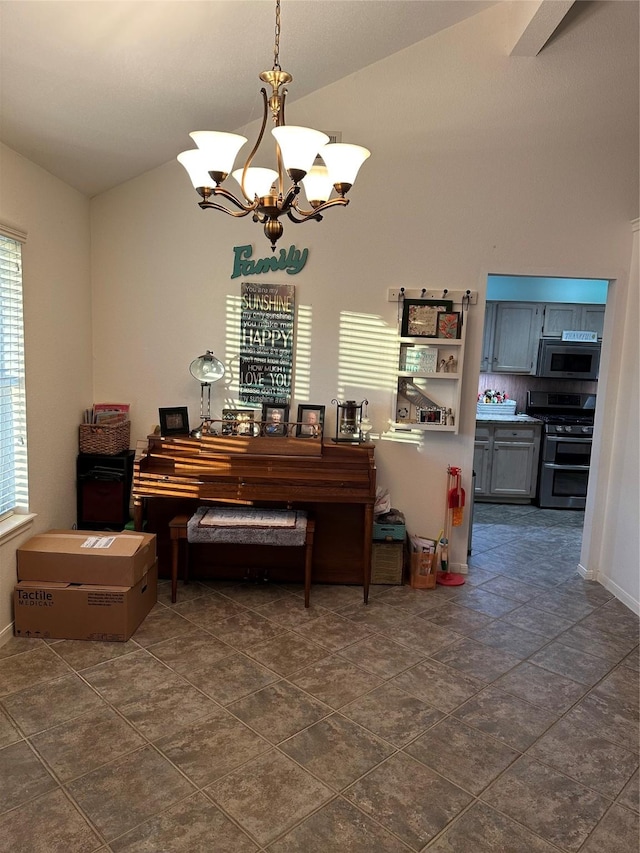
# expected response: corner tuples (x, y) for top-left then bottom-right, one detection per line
(473, 423), (542, 503)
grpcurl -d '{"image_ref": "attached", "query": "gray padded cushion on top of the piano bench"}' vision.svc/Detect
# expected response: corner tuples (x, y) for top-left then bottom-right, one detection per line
(187, 506), (307, 548)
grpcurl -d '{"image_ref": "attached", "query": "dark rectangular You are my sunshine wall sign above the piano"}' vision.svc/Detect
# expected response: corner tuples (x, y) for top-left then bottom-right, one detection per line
(240, 281), (295, 406)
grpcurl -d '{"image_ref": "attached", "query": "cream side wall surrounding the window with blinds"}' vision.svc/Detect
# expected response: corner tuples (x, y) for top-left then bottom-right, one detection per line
(0, 146), (93, 638)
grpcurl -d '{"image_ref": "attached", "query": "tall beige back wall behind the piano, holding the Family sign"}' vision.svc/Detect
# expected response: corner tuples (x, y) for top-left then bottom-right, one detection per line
(92, 3), (638, 592)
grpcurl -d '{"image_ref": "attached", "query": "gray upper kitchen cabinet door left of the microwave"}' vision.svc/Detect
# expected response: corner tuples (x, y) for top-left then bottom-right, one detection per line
(489, 302), (543, 375)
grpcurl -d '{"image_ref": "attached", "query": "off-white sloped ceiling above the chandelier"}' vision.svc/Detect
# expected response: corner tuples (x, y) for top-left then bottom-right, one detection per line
(0, 0), (500, 196)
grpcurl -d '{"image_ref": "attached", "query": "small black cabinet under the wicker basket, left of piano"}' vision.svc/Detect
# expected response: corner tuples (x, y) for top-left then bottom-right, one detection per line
(76, 450), (134, 530)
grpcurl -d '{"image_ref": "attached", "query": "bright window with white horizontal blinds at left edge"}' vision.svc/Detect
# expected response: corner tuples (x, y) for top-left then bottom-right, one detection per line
(0, 227), (28, 519)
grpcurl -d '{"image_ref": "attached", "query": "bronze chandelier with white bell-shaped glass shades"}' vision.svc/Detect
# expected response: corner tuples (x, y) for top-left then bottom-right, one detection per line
(178, 0), (371, 251)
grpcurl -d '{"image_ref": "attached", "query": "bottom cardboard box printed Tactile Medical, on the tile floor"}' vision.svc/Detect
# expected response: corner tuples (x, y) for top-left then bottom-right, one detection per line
(13, 563), (158, 642)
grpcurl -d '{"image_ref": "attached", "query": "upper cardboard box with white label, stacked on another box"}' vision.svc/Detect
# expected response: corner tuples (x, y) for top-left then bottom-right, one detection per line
(17, 530), (156, 587)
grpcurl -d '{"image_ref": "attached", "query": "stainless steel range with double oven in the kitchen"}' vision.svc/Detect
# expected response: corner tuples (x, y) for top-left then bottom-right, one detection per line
(527, 392), (596, 509)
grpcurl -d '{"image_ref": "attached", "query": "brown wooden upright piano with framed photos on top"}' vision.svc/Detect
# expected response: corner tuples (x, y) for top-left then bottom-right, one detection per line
(132, 435), (376, 602)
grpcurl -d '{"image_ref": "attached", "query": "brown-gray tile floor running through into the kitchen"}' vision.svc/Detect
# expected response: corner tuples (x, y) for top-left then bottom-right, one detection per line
(0, 504), (639, 853)
